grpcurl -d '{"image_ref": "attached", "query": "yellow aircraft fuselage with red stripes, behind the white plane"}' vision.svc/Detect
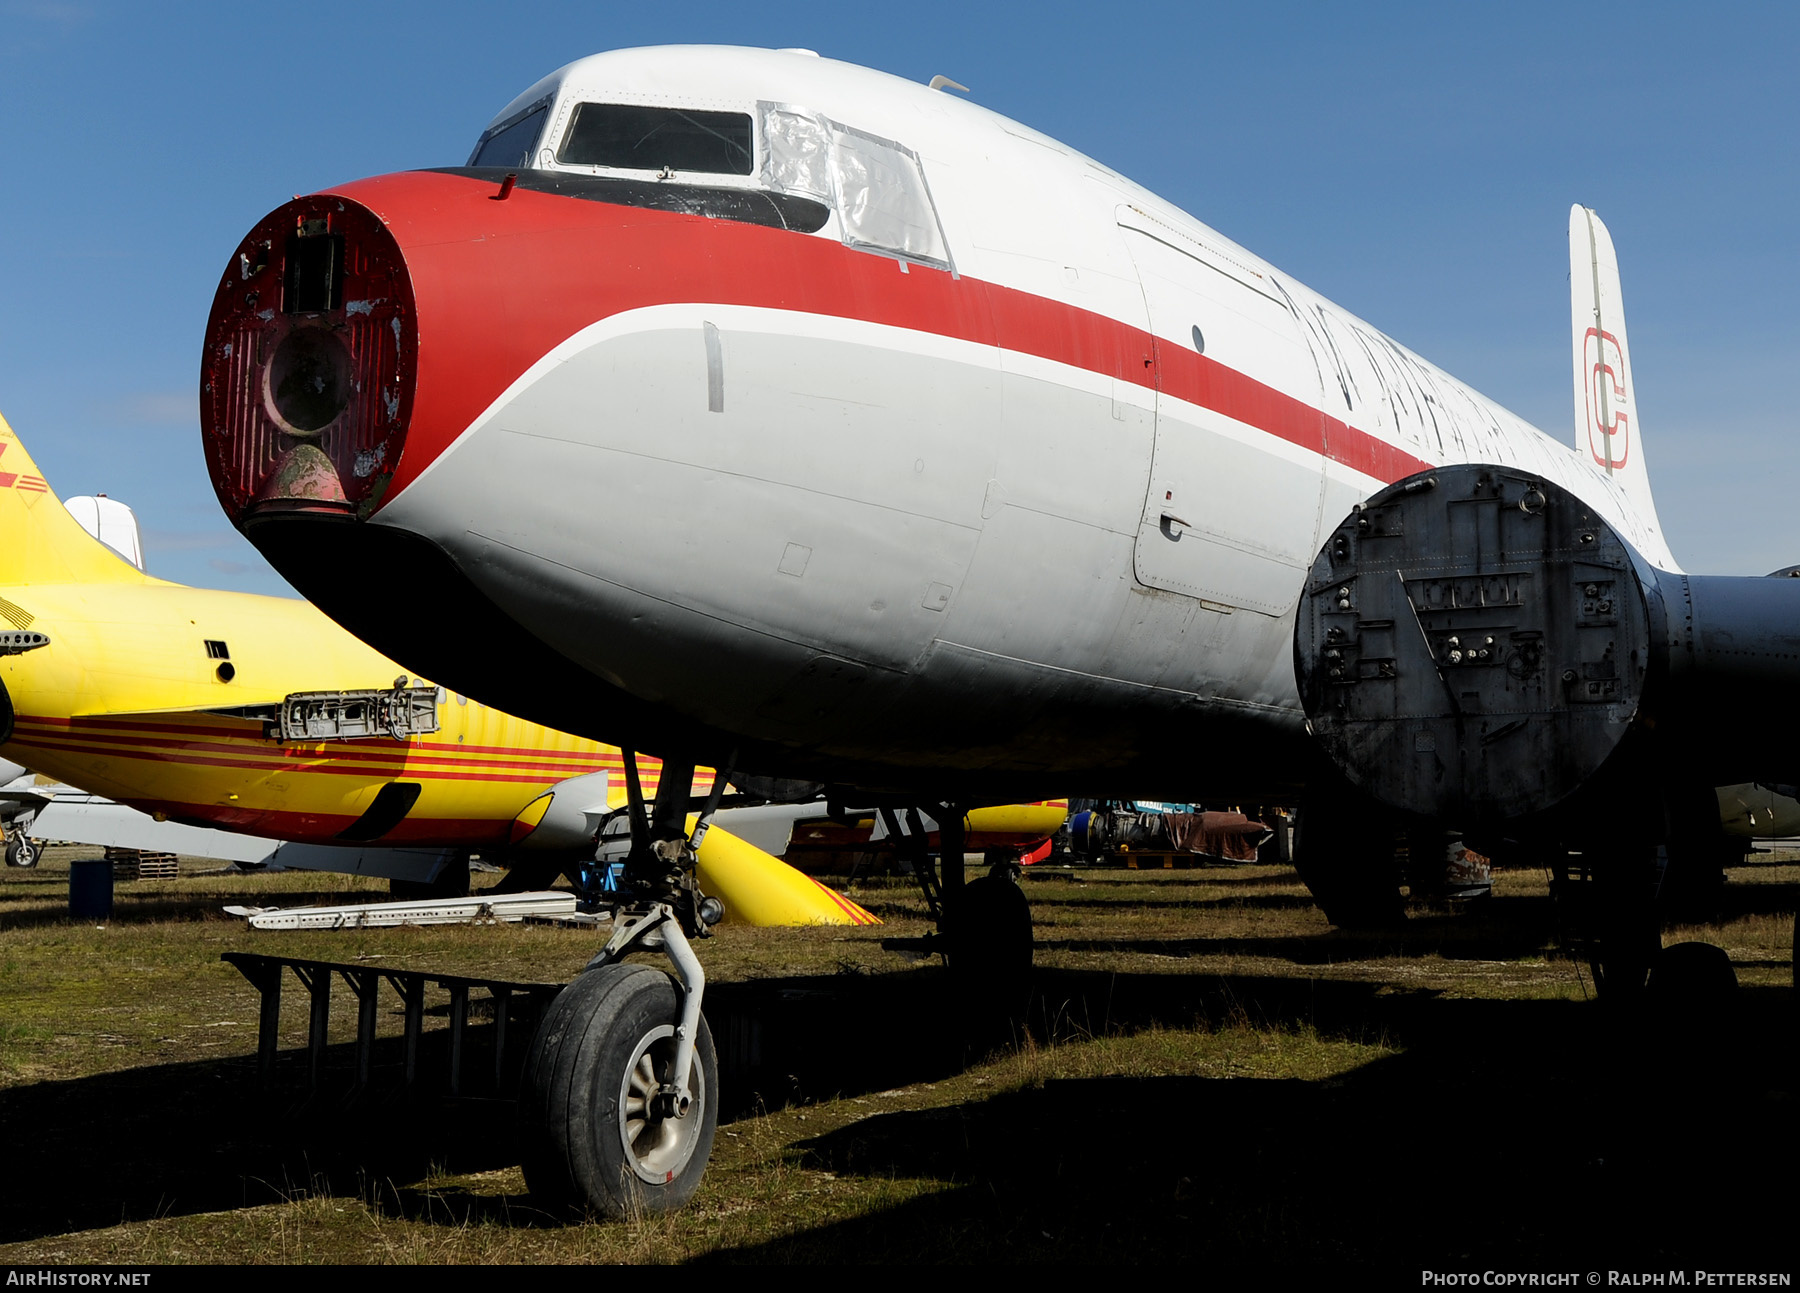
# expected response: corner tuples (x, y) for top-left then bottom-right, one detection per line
(0, 420), (659, 848)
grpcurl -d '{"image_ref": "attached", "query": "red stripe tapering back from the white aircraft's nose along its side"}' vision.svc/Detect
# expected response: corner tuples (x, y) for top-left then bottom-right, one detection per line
(316, 171), (1429, 499)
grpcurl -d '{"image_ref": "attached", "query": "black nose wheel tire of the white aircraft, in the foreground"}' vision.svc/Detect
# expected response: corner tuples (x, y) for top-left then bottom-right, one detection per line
(518, 965), (718, 1217)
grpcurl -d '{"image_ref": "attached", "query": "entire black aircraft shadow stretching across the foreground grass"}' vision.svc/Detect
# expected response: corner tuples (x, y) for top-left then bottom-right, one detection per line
(0, 943), (1795, 1266)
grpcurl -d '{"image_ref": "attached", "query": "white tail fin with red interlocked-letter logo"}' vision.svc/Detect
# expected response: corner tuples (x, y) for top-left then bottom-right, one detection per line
(1570, 205), (1667, 558)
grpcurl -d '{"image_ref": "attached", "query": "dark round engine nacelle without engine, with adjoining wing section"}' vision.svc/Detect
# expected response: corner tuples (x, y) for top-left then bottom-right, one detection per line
(1294, 465), (1800, 828)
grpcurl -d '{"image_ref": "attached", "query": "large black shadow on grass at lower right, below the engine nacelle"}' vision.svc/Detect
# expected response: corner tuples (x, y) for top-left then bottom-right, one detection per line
(704, 976), (1796, 1280)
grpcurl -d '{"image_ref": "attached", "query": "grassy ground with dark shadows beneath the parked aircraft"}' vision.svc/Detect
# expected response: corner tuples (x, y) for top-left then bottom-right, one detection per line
(0, 850), (1800, 1282)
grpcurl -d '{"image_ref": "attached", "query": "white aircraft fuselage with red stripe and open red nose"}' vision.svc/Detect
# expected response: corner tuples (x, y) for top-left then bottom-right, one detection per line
(203, 47), (1674, 798)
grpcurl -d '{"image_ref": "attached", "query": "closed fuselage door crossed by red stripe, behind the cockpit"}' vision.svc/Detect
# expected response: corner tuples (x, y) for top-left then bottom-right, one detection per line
(1120, 207), (1325, 616)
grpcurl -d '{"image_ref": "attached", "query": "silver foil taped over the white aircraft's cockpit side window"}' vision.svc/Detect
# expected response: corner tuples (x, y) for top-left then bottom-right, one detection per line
(760, 103), (952, 270)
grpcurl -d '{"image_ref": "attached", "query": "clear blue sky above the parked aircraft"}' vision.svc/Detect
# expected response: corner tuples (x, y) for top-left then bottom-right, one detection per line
(0, 0), (1800, 592)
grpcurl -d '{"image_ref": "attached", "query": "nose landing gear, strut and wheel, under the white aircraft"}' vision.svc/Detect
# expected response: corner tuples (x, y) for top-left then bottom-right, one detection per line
(518, 751), (725, 1217)
